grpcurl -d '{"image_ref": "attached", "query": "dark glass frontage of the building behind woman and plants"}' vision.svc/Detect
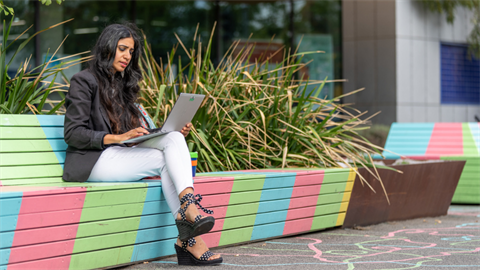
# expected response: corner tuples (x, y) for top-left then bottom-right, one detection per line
(14, 0), (342, 98)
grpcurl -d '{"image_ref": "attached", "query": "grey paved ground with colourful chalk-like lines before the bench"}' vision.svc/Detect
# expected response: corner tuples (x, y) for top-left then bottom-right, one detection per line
(118, 205), (480, 270)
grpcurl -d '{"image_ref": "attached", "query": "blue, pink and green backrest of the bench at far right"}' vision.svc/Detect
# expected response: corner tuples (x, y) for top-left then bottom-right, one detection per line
(383, 123), (480, 158)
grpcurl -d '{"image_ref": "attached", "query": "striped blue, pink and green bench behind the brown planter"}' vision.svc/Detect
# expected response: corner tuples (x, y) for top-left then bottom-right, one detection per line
(383, 123), (480, 204)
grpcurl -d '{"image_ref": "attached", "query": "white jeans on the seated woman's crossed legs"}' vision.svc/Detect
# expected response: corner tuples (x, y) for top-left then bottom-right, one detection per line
(87, 132), (193, 218)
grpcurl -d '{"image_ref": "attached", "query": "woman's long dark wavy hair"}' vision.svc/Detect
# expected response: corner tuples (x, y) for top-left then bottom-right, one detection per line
(90, 24), (143, 134)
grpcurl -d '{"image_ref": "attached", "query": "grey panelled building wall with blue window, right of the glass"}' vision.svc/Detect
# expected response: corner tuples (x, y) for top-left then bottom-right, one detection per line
(342, 0), (480, 125)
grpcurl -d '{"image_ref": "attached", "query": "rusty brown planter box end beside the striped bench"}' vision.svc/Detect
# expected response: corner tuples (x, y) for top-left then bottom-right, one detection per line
(343, 161), (465, 228)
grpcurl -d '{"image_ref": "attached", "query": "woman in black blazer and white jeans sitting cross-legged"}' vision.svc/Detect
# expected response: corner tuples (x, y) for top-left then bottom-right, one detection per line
(63, 24), (222, 265)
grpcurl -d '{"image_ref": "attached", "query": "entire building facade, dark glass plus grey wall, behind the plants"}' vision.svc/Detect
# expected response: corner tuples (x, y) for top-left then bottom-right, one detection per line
(0, 0), (480, 125)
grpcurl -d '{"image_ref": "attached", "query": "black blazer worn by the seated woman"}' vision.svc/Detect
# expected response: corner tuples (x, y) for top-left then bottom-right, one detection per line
(63, 70), (112, 182)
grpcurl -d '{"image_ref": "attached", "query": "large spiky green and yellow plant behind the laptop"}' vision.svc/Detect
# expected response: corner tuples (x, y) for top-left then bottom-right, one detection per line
(141, 25), (386, 193)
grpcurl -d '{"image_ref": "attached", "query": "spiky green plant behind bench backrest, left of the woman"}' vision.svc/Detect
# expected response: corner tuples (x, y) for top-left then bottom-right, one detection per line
(0, 17), (88, 114)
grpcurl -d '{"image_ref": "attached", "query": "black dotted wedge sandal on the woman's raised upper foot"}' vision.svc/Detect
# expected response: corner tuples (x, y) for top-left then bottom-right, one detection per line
(175, 193), (215, 242)
